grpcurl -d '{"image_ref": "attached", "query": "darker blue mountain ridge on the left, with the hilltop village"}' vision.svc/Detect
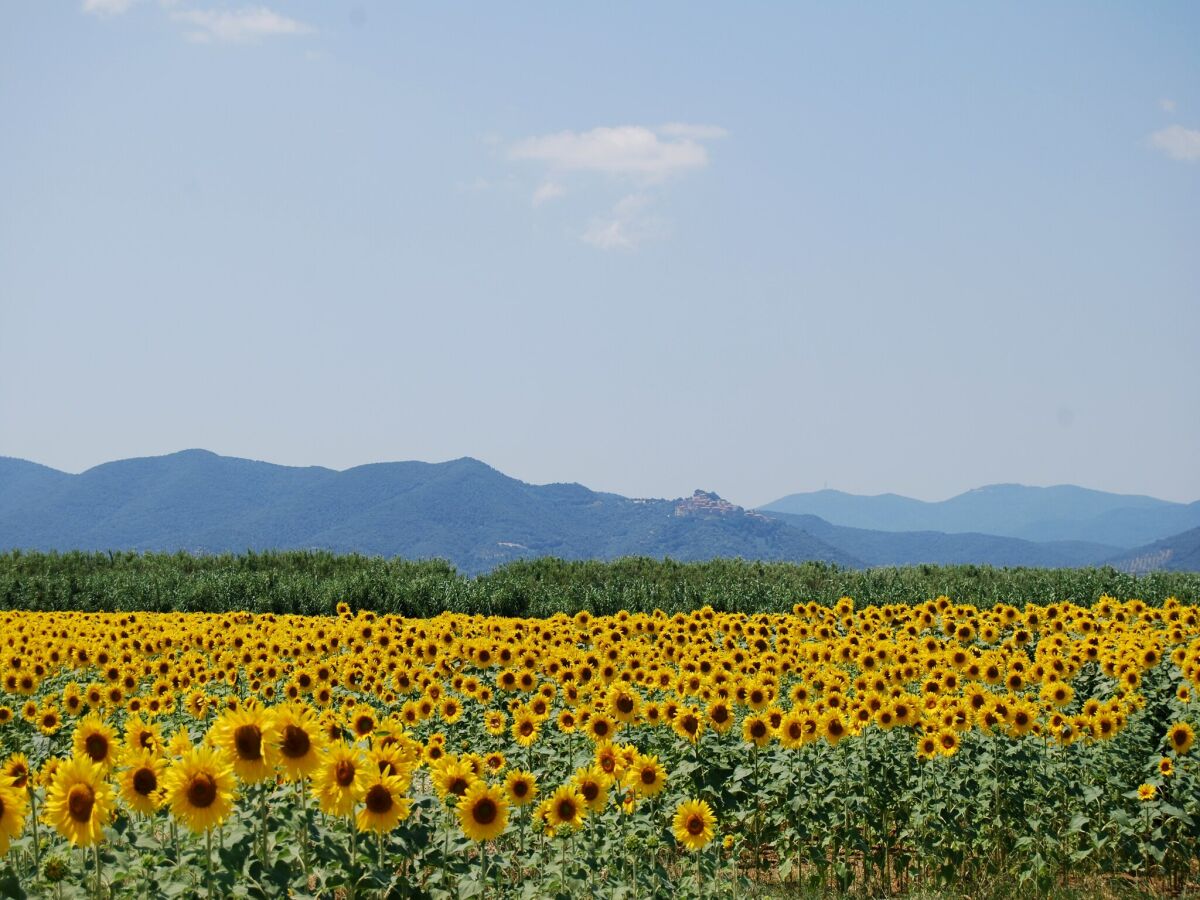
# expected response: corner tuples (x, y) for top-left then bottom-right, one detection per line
(0, 450), (862, 572)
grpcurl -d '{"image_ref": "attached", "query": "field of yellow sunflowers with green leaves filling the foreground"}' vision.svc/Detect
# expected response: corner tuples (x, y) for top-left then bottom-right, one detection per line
(0, 596), (1200, 898)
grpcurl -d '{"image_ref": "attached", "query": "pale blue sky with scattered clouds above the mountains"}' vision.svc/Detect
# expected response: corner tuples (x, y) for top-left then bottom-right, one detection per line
(0, 0), (1200, 506)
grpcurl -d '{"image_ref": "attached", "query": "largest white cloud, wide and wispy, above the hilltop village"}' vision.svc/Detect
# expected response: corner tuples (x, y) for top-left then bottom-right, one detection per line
(509, 125), (708, 179)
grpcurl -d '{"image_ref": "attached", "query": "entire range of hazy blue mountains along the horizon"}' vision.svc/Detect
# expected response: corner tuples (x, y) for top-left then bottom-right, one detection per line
(0, 450), (1200, 574)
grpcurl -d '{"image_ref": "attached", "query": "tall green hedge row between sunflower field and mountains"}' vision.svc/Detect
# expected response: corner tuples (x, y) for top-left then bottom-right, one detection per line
(0, 552), (1200, 617)
